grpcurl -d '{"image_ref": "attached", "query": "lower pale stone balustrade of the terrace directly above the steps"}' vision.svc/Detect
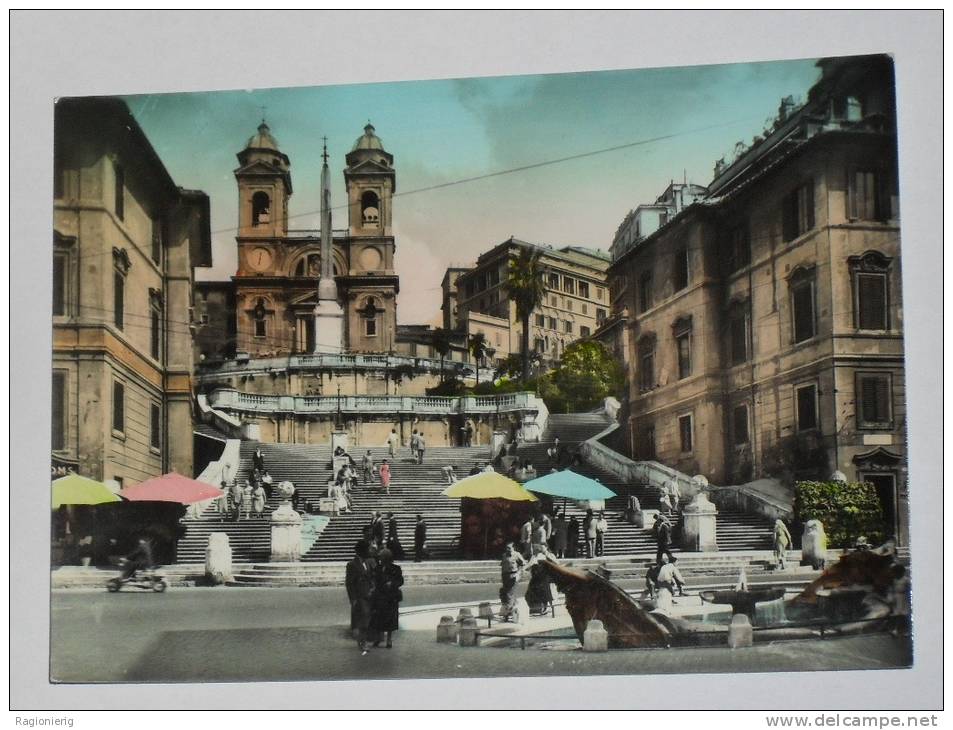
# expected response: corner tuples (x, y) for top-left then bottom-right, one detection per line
(208, 388), (541, 415)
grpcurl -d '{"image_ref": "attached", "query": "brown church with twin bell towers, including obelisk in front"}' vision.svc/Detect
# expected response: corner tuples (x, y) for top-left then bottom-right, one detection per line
(231, 121), (399, 357)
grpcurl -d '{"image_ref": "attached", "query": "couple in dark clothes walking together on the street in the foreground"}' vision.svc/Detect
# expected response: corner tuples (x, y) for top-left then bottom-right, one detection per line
(344, 540), (404, 656)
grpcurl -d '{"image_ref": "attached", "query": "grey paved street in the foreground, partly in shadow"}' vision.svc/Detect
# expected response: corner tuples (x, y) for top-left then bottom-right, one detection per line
(52, 585), (910, 682)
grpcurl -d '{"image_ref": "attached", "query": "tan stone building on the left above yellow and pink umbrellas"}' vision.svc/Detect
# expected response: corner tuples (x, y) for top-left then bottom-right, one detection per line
(52, 98), (211, 484)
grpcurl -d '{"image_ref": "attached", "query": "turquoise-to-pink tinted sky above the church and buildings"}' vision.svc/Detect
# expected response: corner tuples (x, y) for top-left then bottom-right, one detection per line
(126, 59), (818, 323)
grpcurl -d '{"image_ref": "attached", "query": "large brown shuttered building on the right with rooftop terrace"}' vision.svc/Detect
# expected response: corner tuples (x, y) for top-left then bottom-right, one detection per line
(611, 56), (907, 541)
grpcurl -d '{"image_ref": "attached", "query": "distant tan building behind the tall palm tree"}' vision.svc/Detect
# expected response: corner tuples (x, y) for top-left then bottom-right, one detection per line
(444, 238), (609, 367)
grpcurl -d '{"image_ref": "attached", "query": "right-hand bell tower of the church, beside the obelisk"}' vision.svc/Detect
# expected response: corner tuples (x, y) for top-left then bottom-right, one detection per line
(341, 122), (398, 353)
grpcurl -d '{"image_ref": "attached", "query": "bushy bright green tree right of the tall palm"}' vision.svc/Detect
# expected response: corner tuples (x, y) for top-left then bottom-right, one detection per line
(541, 340), (625, 413)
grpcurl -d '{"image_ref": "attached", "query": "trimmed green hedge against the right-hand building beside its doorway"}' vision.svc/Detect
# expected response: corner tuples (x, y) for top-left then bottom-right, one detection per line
(794, 482), (887, 548)
